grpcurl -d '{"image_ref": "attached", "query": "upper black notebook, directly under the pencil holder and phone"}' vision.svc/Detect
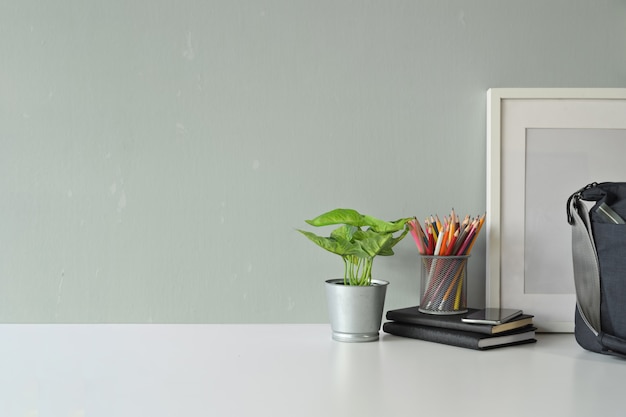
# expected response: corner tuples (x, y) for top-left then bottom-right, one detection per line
(386, 307), (533, 335)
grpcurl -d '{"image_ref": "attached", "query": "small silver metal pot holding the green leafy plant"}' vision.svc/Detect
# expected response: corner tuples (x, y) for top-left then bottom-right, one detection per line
(325, 279), (389, 342)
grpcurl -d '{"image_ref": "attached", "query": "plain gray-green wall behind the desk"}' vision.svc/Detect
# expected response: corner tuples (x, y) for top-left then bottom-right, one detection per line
(0, 0), (626, 323)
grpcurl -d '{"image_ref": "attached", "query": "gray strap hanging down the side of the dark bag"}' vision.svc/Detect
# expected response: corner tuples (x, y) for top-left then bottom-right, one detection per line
(567, 182), (626, 356)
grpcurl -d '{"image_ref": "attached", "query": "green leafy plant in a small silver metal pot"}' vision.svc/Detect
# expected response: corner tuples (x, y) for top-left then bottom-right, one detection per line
(298, 208), (412, 342)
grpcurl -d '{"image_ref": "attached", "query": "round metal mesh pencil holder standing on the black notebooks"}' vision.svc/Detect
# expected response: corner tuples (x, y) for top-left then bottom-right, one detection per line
(419, 255), (469, 314)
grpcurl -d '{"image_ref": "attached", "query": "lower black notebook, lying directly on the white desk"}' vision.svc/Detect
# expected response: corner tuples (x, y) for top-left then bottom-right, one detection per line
(383, 321), (537, 350)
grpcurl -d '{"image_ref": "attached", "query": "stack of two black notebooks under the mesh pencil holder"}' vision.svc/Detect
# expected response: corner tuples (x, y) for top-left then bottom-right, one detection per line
(383, 307), (537, 350)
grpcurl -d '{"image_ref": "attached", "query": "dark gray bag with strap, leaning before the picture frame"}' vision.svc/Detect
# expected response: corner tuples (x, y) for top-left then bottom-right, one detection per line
(567, 182), (626, 358)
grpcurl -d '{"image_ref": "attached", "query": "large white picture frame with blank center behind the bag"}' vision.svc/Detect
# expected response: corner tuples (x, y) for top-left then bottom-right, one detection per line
(485, 88), (626, 333)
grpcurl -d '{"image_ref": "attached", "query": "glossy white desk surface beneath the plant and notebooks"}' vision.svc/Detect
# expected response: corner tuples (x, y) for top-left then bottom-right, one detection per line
(0, 324), (626, 417)
